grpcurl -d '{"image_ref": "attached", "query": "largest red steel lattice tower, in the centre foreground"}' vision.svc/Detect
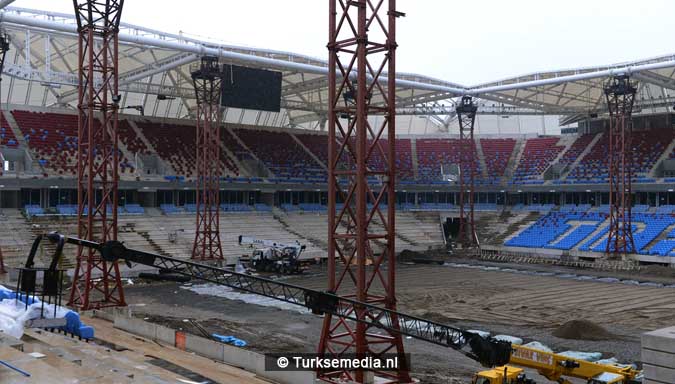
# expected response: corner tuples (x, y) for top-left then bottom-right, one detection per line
(318, 0), (410, 383)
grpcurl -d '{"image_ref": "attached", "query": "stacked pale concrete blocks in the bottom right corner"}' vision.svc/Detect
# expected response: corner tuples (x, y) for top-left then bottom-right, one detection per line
(642, 327), (675, 384)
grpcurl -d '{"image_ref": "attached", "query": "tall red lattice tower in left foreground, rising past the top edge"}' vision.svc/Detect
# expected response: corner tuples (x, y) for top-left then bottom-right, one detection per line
(68, 0), (126, 310)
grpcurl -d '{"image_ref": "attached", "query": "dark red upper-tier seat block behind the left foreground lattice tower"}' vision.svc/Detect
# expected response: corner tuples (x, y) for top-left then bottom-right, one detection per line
(12, 110), (134, 175)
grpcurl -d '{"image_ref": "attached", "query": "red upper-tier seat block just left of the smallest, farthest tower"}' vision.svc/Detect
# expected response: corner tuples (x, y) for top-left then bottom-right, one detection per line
(416, 139), (483, 185)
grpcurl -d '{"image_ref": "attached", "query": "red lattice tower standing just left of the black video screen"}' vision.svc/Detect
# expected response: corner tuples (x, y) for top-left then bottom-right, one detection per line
(192, 56), (223, 260)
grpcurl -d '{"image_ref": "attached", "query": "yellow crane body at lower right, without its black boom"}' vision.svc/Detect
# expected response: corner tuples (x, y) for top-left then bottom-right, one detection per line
(473, 345), (640, 384)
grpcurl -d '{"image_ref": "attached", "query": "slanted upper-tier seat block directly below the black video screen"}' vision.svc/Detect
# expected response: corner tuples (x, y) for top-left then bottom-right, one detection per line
(235, 129), (326, 182)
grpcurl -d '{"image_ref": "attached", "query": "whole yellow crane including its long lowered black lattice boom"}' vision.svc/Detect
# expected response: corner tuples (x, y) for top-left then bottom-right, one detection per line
(26, 232), (641, 384)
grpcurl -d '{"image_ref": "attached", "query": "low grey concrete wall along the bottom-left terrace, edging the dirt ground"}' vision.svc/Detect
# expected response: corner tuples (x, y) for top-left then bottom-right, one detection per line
(114, 315), (315, 384)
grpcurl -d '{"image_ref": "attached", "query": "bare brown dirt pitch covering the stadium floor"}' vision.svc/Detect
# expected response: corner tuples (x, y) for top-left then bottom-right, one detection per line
(126, 264), (675, 383)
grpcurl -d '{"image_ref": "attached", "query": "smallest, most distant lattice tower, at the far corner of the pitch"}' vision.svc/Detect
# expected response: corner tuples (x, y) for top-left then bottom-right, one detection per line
(456, 96), (478, 248)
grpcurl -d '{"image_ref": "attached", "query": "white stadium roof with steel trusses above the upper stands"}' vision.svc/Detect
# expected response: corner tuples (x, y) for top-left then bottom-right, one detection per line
(0, 4), (675, 130)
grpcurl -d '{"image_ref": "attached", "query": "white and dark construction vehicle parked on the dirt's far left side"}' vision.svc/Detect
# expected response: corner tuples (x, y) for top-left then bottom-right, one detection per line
(239, 235), (307, 275)
